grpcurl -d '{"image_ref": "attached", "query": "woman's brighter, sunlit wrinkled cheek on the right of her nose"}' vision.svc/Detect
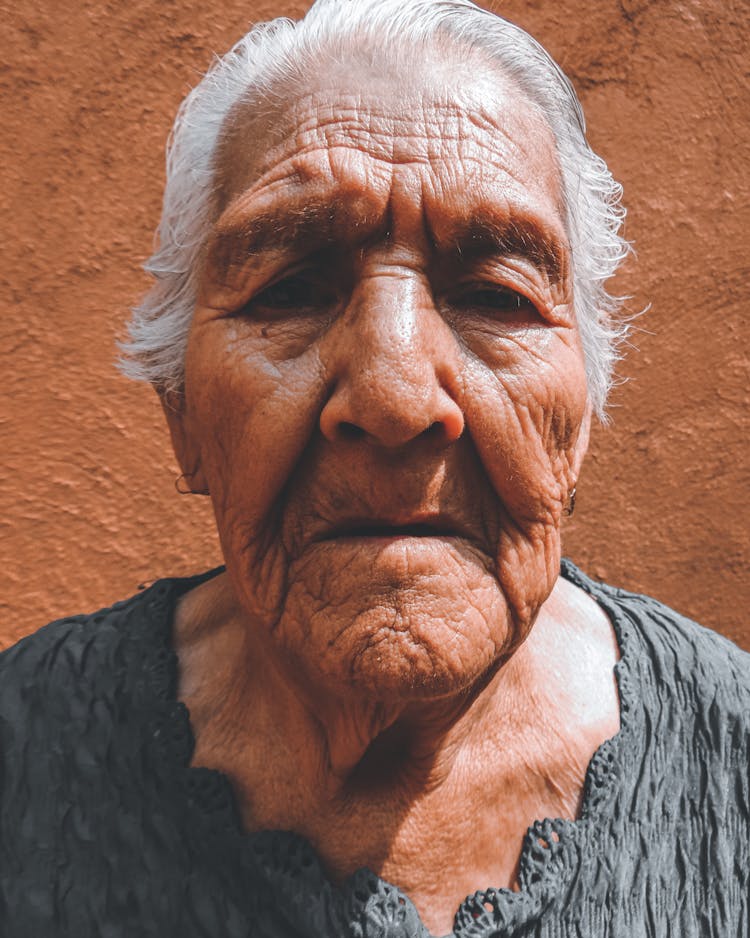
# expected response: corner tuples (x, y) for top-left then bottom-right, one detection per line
(456, 330), (587, 645)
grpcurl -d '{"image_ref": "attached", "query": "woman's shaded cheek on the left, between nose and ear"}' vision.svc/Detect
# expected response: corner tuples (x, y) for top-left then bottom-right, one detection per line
(186, 322), (326, 614)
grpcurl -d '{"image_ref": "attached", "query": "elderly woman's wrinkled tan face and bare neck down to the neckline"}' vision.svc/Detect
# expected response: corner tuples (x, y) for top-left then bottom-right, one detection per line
(170, 67), (616, 931)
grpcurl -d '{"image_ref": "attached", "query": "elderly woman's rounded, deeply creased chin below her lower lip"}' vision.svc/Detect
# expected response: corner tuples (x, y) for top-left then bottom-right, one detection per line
(274, 556), (512, 702)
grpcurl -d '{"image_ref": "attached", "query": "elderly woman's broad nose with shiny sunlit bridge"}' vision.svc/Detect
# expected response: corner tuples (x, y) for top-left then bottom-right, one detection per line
(320, 273), (464, 448)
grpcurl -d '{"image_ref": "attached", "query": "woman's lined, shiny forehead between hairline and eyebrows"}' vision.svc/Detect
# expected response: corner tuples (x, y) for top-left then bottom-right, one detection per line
(216, 59), (563, 241)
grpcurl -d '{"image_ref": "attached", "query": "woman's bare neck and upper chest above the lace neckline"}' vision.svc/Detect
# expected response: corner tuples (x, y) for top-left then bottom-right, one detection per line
(175, 577), (619, 933)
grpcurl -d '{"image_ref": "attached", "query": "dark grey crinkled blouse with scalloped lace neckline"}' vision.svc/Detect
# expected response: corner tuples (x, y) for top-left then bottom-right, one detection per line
(0, 563), (750, 938)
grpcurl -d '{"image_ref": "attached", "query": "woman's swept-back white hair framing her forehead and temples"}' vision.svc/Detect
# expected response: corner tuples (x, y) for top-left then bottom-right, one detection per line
(121, 0), (628, 417)
